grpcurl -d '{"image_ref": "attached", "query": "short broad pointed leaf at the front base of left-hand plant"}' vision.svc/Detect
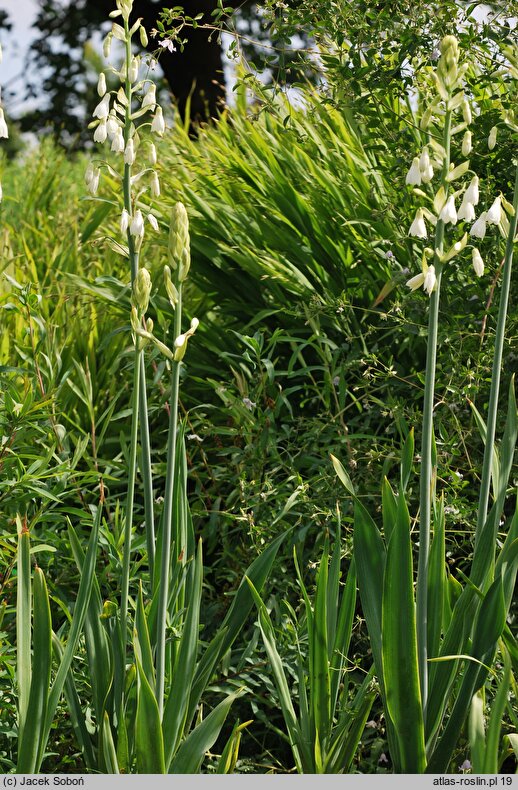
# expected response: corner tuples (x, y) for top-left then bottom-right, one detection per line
(135, 658), (166, 774)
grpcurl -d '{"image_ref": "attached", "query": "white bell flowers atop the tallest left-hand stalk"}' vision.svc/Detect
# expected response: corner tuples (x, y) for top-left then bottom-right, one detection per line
(85, 0), (166, 246)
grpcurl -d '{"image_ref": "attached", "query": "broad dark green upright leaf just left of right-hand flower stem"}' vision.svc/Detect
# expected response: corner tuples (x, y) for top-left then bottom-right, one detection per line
(382, 492), (426, 773)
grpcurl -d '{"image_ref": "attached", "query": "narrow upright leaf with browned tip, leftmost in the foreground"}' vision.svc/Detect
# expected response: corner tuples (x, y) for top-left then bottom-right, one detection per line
(16, 517), (32, 738)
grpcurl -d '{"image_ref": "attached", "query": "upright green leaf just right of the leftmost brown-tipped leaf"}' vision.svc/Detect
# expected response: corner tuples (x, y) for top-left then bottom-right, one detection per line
(16, 568), (52, 774)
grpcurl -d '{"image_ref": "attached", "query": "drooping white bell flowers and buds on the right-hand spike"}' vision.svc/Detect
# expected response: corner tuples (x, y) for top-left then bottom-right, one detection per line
(405, 36), (513, 295)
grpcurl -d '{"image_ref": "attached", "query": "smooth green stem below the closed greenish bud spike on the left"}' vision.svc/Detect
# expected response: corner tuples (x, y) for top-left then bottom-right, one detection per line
(156, 282), (182, 716)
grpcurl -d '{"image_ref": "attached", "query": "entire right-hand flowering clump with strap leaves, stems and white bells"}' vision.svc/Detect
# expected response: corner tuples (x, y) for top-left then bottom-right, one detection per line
(333, 35), (518, 773)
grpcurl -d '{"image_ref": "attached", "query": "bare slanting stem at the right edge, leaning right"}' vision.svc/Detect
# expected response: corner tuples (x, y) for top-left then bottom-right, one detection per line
(475, 162), (518, 546)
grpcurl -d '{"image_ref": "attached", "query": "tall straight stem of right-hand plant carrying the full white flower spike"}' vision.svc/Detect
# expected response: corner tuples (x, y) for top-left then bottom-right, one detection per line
(416, 111), (451, 711)
